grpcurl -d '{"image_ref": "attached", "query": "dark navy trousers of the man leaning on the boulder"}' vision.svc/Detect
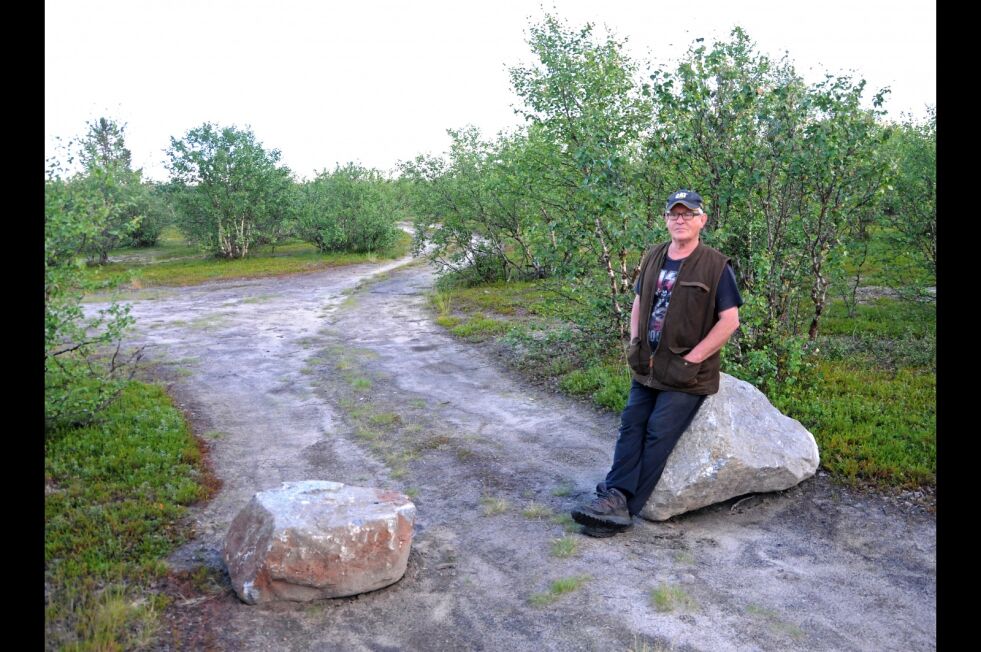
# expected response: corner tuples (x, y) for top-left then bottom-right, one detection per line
(606, 380), (705, 516)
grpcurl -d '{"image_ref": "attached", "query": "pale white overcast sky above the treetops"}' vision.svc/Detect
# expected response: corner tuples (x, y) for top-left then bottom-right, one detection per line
(44, 0), (937, 180)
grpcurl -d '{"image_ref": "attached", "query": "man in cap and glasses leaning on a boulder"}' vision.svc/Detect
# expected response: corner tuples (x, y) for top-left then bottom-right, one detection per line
(572, 190), (743, 537)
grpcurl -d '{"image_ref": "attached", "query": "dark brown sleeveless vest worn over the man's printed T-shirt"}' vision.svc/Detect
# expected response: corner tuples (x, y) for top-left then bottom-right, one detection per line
(627, 242), (729, 394)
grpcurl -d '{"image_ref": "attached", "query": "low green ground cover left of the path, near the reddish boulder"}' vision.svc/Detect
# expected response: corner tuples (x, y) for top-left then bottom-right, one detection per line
(44, 382), (209, 650)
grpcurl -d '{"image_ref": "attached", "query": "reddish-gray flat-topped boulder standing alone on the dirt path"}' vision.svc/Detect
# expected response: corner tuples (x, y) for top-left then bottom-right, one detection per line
(224, 480), (416, 604)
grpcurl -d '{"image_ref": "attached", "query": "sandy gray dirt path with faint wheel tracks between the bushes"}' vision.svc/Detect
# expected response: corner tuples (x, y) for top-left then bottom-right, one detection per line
(90, 253), (936, 652)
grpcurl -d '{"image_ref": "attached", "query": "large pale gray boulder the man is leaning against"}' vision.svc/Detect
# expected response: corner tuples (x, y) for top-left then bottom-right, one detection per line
(640, 374), (820, 521)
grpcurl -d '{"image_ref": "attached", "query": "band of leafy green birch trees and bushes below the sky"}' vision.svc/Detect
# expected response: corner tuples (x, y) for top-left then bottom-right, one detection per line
(45, 15), (936, 428)
